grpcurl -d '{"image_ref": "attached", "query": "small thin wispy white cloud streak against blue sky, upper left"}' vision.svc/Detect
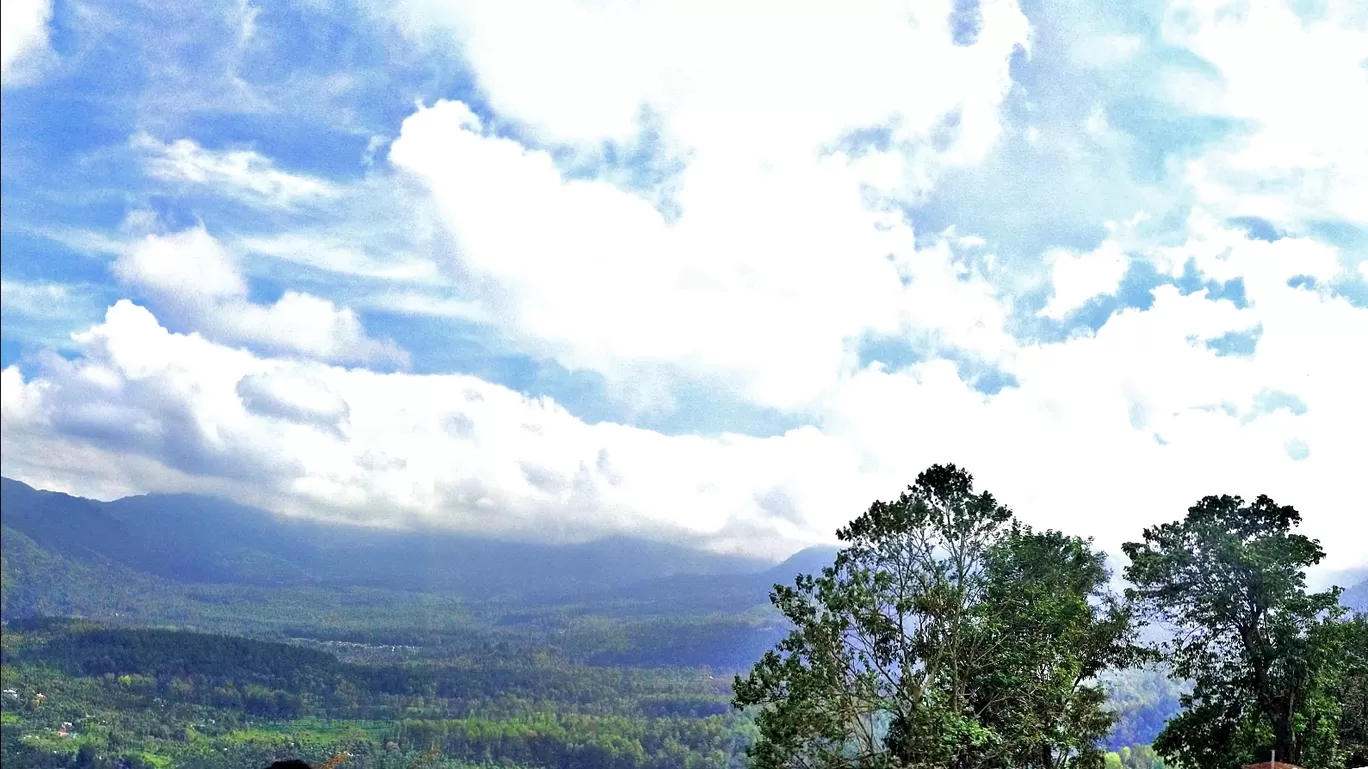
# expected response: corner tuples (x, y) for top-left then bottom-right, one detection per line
(131, 134), (341, 205)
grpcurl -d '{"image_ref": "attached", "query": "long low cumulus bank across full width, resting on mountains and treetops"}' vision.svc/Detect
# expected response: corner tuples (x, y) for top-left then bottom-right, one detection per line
(3, 222), (1368, 568)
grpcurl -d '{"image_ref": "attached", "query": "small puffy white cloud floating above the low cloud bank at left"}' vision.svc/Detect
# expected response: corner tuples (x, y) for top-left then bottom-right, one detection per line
(114, 227), (408, 364)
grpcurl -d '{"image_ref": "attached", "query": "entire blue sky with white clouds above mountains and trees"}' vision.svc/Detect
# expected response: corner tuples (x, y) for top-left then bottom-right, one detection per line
(0, 0), (1368, 571)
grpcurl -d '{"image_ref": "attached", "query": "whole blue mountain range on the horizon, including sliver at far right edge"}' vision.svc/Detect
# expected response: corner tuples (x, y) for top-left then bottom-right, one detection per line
(0, 479), (1368, 614)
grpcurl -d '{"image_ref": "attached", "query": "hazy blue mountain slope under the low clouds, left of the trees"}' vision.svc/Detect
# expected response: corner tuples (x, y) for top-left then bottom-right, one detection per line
(0, 479), (767, 601)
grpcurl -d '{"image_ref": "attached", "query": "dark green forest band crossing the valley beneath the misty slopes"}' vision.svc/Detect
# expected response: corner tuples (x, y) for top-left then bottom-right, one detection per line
(0, 618), (729, 718)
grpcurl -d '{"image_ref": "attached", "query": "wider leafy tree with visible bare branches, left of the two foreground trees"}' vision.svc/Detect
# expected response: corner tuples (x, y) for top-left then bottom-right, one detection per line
(733, 465), (1134, 769)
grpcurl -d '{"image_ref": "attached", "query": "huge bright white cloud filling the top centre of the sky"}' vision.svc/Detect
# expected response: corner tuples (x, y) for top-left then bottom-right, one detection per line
(369, 0), (1029, 409)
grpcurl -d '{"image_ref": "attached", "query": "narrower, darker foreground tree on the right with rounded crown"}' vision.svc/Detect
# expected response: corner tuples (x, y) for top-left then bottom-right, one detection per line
(1122, 497), (1345, 766)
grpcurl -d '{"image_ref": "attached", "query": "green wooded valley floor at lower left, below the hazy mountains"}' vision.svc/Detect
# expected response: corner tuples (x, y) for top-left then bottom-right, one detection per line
(3, 620), (752, 769)
